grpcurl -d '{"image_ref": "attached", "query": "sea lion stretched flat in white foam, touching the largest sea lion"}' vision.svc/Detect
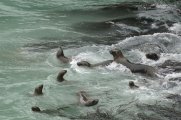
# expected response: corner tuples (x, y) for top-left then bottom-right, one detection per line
(77, 60), (113, 67)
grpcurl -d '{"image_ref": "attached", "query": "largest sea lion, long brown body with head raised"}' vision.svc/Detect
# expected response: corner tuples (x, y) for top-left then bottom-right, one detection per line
(110, 49), (156, 77)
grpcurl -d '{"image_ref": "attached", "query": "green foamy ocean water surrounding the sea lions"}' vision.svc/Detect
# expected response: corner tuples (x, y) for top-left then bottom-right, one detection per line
(0, 0), (181, 120)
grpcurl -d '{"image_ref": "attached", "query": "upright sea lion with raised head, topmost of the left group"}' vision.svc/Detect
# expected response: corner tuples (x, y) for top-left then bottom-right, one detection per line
(56, 47), (71, 63)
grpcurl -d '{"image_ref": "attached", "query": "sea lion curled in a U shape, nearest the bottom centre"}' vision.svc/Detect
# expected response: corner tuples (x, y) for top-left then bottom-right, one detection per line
(79, 91), (99, 107)
